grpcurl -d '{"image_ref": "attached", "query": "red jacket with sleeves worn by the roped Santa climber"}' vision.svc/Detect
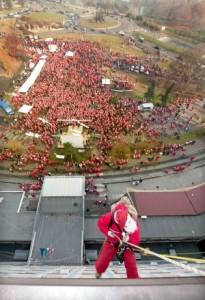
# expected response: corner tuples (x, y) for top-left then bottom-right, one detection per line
(98, 212), (140, 245)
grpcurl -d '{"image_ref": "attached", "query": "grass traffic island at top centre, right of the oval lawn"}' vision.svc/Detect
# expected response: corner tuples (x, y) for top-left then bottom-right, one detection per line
(80, 17), (118, 29)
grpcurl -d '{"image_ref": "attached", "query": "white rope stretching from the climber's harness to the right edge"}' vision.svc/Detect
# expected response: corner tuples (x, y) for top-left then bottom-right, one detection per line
(113, 232), (205, 276)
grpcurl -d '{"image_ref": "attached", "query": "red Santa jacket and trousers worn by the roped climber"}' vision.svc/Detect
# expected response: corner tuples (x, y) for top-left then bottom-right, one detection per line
(96, 204), (140, 278)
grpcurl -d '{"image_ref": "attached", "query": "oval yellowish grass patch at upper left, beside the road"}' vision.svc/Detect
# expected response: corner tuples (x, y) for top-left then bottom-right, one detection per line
(25, 12), (63, 24)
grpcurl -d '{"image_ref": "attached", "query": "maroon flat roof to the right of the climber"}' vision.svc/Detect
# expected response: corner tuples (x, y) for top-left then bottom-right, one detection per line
(135, 185), (205, 216)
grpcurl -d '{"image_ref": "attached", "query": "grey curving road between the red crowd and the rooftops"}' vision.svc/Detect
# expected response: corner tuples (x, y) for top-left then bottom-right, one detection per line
(0, 152), (205, 215)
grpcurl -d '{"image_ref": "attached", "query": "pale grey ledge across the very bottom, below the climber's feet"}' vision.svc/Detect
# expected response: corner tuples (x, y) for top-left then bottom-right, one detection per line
(0, 277), (205, 300)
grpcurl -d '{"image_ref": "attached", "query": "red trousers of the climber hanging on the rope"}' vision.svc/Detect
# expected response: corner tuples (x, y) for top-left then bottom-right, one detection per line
(95, 241), (139, 278)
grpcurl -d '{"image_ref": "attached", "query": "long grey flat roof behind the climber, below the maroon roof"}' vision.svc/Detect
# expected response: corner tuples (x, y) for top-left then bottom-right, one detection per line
(85, 214), (205, 242)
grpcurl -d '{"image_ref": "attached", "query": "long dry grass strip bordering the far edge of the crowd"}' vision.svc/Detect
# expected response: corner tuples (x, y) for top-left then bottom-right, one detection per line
(39, 31), (145, 57)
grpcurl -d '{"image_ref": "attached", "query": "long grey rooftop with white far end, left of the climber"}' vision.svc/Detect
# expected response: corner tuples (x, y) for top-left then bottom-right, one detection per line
(29, 176), (85, 265)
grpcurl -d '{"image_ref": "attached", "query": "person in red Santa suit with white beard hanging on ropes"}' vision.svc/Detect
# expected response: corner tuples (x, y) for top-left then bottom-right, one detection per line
(95, 196), (140, 279)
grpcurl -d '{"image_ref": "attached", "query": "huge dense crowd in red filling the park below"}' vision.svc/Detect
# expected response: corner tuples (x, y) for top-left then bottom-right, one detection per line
(0, 39), (199, 177)
